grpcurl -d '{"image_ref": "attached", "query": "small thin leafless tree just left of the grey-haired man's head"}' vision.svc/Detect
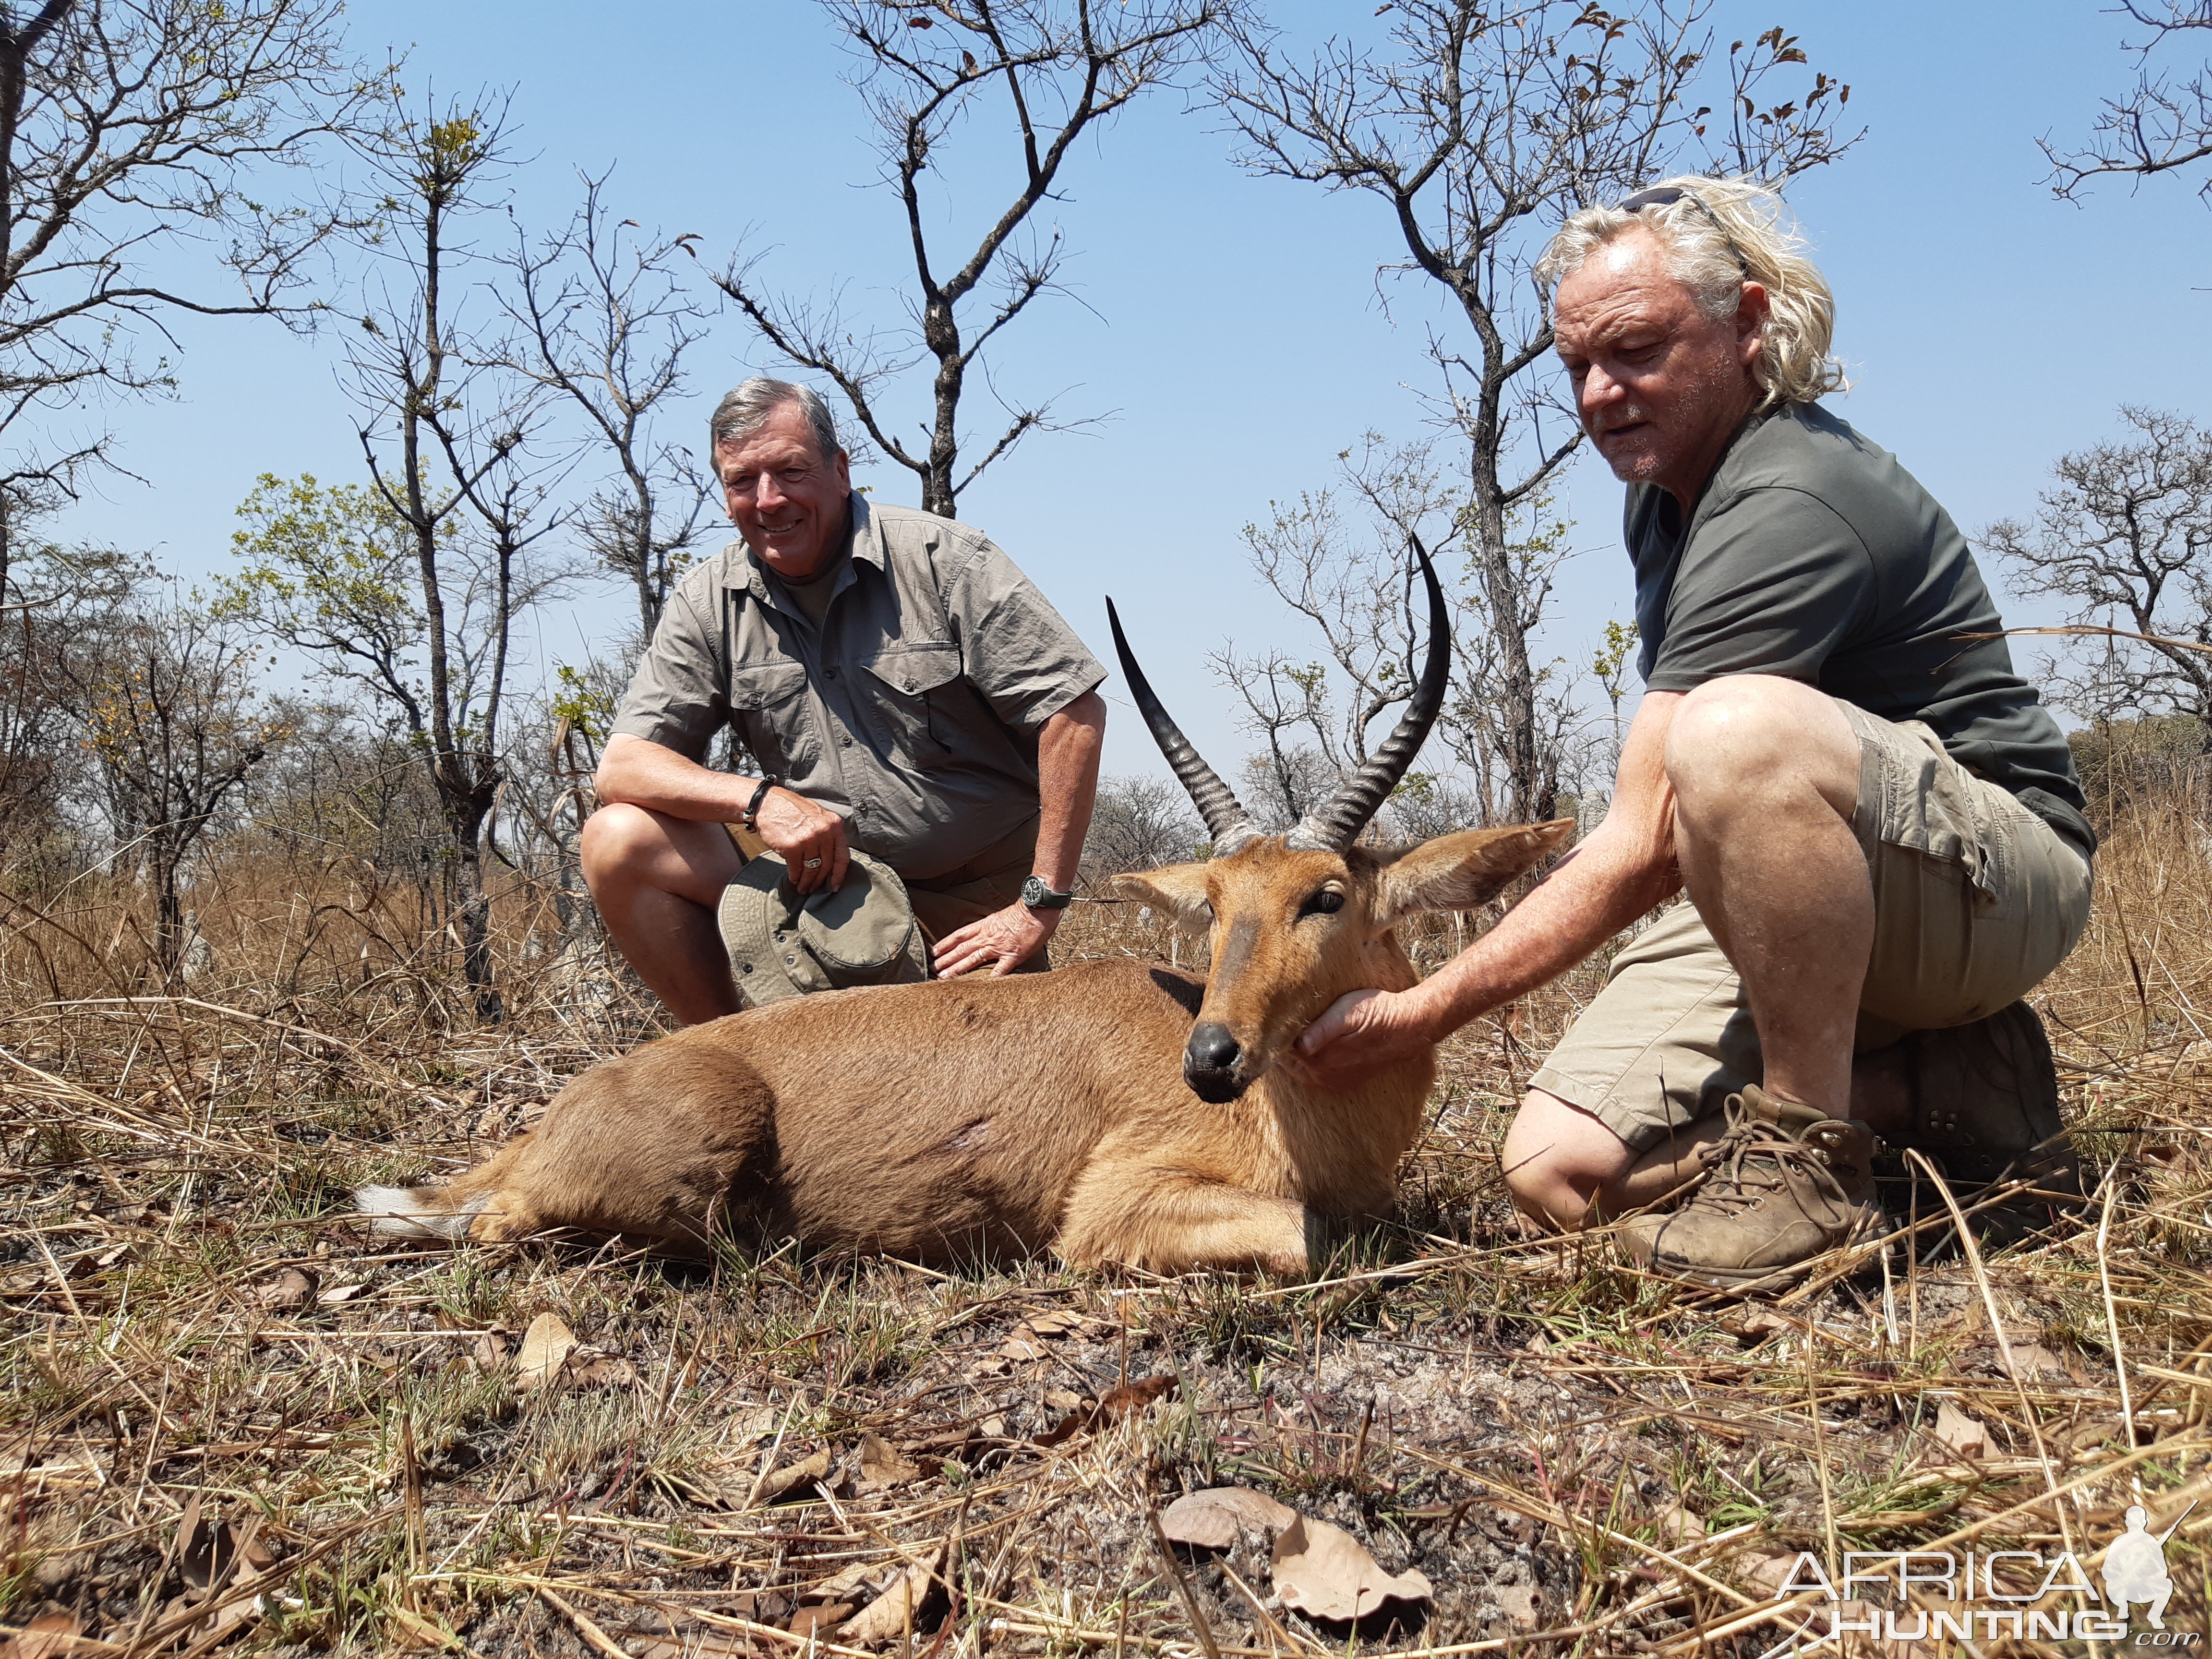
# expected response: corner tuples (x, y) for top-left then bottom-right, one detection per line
(500, 172), (712, 641)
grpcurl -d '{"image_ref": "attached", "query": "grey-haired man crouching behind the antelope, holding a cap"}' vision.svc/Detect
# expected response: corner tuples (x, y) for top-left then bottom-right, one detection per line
(584, 378), (1106, 1024)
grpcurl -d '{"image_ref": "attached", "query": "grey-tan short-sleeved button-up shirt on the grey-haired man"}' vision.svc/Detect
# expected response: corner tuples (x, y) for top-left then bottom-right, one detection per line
(615, 493), (1106, 880)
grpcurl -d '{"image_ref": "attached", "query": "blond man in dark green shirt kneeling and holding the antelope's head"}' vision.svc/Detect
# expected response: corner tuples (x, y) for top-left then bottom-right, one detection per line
(1301, 179), (2095, 1287)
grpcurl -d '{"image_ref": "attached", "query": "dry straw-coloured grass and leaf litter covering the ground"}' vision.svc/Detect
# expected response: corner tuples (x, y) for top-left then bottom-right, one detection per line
(0, 807), (2212, 1659)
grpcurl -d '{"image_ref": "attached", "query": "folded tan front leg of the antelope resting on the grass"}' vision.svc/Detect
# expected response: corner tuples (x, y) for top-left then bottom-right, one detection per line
(1058, 1157), (1307, 1278)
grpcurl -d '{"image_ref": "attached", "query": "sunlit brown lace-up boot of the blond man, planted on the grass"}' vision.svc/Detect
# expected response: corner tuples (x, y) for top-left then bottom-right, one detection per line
(1622, 1086), (1882, 1289)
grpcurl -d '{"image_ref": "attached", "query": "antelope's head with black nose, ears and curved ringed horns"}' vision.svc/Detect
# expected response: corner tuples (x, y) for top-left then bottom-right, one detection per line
(1106, 540), (1575, 1102)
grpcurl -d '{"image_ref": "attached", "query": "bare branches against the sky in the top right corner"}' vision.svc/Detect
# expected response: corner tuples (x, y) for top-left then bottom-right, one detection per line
(2040, 0), (2212, 201)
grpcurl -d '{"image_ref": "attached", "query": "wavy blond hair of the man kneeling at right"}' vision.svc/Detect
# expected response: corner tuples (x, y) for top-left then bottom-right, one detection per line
(1535, 172), (1851, 409)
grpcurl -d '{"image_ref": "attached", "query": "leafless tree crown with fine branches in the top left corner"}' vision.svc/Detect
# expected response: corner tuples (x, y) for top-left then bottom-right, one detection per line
(0, 0), (389, 506)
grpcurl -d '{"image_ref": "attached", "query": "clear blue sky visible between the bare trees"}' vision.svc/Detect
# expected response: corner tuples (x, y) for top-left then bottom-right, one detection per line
(48, 0), (2212, 792)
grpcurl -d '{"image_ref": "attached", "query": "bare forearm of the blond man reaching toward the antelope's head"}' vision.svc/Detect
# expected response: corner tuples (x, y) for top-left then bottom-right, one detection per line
(1409, 834), (1681, 1037)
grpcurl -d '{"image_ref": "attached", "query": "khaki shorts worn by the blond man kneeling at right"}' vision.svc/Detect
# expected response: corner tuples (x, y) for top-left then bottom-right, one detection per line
(1528, 701), (2091, 1153)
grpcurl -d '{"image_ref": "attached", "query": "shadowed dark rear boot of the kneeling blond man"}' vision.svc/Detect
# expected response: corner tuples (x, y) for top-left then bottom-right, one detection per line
(1889, 1002), (2081, 1221)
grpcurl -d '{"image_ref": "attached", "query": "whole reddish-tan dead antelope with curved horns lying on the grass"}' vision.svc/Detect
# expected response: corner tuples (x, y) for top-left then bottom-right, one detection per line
(356, 544), (1573, 1274)
